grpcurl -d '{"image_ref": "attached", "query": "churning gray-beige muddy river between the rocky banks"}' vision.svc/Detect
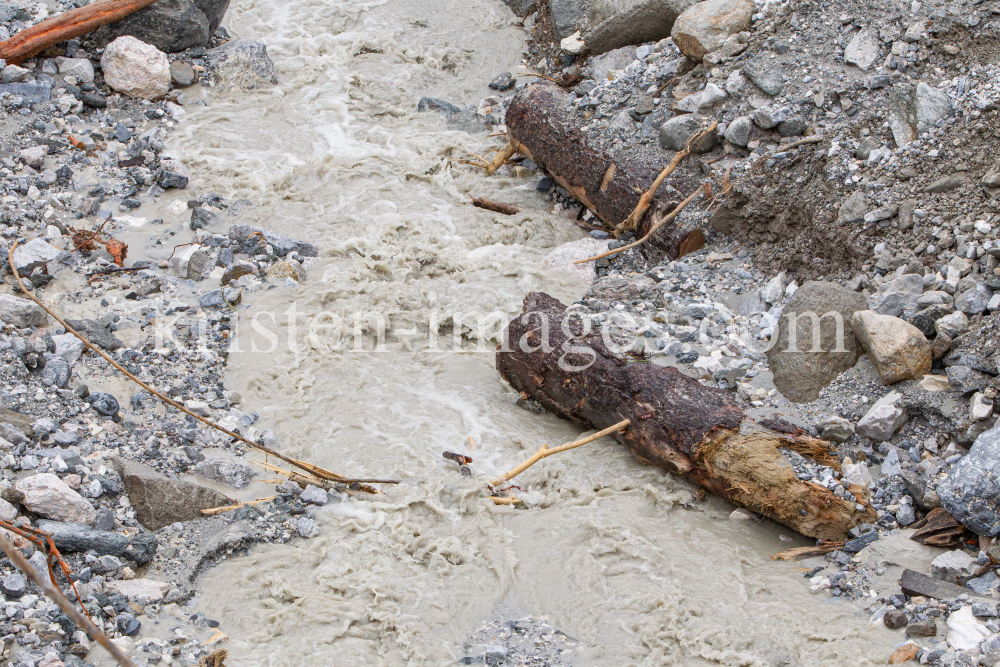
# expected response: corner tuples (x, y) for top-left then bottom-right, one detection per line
(162, 0), (893, 667)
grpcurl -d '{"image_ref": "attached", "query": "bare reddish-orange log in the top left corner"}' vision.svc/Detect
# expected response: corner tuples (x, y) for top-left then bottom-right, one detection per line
(0, 0), (156, 65)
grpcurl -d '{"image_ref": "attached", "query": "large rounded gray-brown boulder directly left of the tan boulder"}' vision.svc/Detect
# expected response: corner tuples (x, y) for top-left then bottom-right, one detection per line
(767, 282), (865, 402)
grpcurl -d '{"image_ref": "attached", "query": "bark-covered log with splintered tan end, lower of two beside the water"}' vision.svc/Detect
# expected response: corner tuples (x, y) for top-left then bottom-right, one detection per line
(496, 292), (876, 540)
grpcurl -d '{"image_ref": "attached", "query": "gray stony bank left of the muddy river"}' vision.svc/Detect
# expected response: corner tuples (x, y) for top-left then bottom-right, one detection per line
(0, 3), (336, 667)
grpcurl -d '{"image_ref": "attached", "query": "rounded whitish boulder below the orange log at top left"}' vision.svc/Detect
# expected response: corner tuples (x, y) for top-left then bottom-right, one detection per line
(101, 35), (170, 100)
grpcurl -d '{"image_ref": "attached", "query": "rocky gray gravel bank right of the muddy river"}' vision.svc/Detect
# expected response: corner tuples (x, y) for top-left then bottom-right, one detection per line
(406, 0), (1000, 665)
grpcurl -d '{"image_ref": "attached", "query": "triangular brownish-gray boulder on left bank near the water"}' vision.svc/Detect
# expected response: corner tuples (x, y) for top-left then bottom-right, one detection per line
(112, 456), (233, 530)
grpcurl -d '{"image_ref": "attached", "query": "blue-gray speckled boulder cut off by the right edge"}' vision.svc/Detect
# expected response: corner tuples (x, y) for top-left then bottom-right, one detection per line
(937, 427), (1000, 537)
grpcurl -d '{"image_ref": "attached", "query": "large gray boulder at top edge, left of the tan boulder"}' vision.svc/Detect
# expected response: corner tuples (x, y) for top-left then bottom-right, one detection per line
(584, 0), (695, 53)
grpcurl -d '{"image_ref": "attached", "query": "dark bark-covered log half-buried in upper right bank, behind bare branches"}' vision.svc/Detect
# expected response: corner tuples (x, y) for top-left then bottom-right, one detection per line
(506, 84), (705, 259)
